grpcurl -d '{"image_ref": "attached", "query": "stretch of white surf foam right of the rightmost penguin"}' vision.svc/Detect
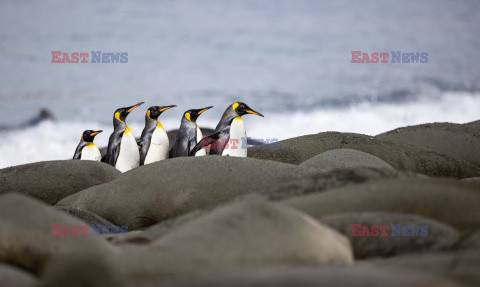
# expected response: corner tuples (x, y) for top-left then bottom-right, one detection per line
(244, 93), (480, 139)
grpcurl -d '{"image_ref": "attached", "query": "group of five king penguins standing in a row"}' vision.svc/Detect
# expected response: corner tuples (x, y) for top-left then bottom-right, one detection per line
(73, 102), (263, 172)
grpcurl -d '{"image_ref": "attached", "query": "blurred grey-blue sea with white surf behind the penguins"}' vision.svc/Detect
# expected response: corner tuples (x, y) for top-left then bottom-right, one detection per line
(0, 0), (480, 167)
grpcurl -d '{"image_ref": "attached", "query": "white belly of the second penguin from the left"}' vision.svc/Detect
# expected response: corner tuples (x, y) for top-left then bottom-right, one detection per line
(115, 127), (140, 172)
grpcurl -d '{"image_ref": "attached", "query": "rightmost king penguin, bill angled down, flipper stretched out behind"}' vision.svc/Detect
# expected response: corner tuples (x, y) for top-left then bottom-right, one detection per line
(191, 102), (263, 157)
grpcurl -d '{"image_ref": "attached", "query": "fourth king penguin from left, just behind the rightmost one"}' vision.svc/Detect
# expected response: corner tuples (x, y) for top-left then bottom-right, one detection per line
(170, 106), (213, 158)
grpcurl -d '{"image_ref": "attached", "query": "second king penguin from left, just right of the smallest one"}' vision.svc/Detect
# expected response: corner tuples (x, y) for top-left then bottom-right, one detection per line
(105, 102), (143, 172)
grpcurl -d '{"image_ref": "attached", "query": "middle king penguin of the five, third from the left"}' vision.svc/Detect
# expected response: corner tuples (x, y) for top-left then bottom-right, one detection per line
(137, 105), (176, 165)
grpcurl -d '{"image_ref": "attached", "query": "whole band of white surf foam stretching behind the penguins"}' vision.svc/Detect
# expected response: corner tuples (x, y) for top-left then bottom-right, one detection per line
(0, 93), (480, 168)
